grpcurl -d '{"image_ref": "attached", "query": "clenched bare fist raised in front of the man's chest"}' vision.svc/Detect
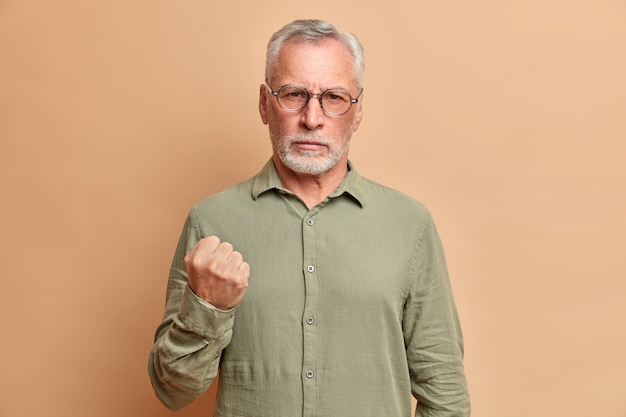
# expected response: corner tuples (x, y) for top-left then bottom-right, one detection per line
(185, 236), (250, 310)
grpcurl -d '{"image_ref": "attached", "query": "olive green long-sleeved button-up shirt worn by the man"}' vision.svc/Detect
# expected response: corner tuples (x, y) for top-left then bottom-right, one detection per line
(149, 161), (470, 417)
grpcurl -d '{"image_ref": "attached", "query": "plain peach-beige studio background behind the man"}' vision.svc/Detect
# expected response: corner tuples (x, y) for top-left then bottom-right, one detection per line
(0, 0), (626, 417)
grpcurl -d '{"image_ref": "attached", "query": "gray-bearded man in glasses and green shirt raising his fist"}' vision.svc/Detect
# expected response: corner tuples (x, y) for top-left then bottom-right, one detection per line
(149, 20), (469, 417)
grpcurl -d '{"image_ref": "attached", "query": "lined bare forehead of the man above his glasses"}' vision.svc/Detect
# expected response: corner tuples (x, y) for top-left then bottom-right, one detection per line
(273, 39), (356, 89)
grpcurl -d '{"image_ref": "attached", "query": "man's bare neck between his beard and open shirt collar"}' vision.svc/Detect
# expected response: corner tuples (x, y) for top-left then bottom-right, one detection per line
(274, 158), (348, 209)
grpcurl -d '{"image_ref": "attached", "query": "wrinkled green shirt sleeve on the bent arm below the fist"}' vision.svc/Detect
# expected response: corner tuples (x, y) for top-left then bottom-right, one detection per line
(148, 212), (235, 410)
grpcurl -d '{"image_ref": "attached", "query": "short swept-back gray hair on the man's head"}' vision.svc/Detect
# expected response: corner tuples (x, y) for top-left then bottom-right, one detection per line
(265, 19), (365, 89)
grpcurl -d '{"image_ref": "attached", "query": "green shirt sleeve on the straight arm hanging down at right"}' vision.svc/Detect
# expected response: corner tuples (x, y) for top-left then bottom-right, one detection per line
(403, 217), (470, 417)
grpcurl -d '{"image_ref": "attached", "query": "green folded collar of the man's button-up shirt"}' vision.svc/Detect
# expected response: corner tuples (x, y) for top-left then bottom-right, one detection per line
(252, 159), (366, 208)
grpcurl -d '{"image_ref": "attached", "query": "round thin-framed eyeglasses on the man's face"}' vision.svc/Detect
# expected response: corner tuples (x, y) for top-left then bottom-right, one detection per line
(265, 80), (363, 116)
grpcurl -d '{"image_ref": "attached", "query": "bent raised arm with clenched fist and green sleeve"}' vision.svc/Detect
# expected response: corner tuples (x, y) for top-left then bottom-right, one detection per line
(148, 212), (249, 410)
